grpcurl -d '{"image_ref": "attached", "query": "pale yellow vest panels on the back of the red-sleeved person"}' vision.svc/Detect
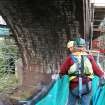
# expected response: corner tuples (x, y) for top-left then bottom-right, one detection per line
(68, 54), (93, 81)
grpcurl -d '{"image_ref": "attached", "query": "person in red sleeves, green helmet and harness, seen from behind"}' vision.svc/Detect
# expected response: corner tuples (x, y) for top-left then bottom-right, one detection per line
(60, 38), (105, 105)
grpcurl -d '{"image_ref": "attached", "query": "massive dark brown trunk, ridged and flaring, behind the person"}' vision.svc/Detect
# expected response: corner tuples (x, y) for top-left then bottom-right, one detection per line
(0, 0), (89, 93)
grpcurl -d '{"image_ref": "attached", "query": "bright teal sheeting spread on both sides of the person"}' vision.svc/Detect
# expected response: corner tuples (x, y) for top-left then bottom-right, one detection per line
(18, 75), (105, 105)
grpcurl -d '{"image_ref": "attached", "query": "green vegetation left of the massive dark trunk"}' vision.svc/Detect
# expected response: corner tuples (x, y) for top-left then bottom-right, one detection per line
(0, 37), (19, 92)
